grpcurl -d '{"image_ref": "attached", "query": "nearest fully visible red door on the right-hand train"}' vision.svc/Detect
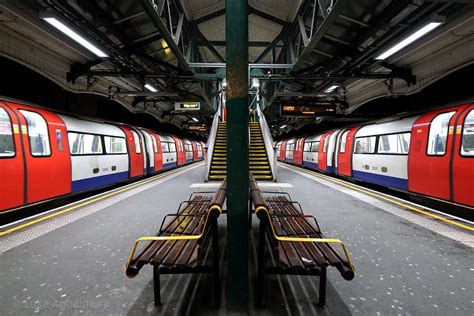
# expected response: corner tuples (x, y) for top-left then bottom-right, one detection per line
(408, 106), (461, 200)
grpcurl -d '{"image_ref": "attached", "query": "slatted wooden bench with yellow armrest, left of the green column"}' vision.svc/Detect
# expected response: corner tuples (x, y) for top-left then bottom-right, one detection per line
(125, 180), (226, 305)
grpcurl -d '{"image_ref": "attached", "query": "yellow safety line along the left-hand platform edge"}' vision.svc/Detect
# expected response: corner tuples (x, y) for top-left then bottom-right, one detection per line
(0, 162), (204, 237)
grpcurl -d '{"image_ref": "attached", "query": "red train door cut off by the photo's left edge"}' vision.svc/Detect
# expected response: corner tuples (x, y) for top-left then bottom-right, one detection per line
(0, 103), (26, 210)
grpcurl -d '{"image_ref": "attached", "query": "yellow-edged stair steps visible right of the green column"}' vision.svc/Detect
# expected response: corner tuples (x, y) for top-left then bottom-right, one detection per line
(249, 122), (273, 181)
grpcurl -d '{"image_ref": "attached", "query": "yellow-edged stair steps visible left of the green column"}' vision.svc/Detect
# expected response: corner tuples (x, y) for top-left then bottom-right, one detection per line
(209, 122), (227, 181)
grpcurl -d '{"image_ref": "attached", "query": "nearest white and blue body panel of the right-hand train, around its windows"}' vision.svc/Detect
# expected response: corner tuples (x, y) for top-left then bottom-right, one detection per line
(352, 117), (418, 190)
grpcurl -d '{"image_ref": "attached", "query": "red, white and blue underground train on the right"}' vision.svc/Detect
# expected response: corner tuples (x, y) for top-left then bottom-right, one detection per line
(276, 102), (474, 207)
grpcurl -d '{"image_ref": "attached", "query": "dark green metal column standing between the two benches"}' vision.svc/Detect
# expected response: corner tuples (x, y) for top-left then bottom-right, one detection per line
(226, 0), (249, 313)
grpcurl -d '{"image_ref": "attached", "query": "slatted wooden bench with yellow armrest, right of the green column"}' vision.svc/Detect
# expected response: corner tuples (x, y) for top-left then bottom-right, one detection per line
(250, 175), (355, 307)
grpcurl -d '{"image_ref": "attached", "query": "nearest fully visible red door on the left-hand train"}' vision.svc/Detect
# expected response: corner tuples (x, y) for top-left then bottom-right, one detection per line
(6, 102), (72, 204)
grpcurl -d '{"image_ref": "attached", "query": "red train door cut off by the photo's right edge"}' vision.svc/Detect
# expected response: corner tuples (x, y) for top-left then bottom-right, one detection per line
(451, 104), (474, 206)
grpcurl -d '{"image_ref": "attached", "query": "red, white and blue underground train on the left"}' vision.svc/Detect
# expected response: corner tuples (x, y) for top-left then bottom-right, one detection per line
(0, 99), (204, 212)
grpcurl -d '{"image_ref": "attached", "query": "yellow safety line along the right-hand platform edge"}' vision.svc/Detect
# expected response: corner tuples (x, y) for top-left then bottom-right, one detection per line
(282, 165), (474, 231)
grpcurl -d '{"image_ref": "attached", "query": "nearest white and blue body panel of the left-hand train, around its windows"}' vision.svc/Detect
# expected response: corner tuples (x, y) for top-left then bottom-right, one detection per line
(59, 115), (129, 192)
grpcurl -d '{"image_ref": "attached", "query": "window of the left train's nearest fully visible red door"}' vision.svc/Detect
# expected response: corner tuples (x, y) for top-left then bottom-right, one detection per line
(20, 110), (51, 157)
